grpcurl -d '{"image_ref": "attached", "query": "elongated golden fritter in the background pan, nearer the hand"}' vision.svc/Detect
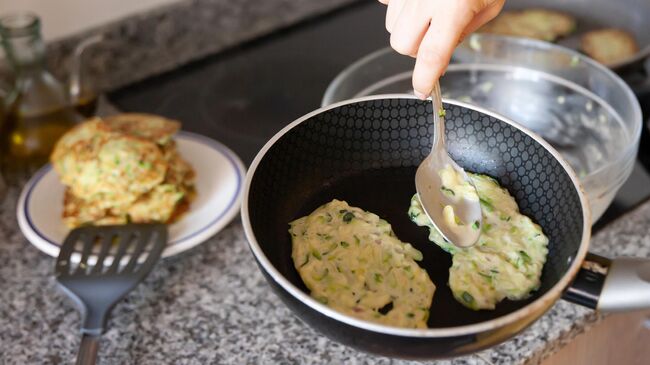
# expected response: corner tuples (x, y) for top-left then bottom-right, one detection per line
(479, 9), (576, 42)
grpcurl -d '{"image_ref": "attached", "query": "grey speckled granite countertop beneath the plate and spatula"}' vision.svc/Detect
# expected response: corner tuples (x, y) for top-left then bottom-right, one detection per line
(0, 169), (650, 364)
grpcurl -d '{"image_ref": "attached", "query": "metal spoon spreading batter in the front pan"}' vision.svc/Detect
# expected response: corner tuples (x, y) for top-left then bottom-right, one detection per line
(415, 81), (483, 247)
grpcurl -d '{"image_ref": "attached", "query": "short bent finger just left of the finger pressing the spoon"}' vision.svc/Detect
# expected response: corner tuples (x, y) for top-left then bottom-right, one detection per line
(390, 0), (431, 57)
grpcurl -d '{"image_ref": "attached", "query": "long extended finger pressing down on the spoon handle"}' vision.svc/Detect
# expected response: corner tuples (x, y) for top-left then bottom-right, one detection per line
(413, 2), (475, 99)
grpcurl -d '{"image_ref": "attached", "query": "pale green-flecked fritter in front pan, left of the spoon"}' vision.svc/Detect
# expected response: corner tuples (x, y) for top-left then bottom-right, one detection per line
(289, 200), (436, 328)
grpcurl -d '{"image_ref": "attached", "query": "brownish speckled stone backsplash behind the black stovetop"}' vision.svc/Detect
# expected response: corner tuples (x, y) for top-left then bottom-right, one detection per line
(39, 0), (359, 90)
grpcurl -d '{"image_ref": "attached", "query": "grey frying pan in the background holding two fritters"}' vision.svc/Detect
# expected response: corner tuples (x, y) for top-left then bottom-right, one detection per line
(496, 0), (650, 72)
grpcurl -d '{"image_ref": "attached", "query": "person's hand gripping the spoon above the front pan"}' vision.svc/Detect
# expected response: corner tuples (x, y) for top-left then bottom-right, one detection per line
(379, 0), (505, 99)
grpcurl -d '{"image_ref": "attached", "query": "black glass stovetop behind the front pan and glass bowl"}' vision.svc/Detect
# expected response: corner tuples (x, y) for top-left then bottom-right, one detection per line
(109, 2), (650, 230)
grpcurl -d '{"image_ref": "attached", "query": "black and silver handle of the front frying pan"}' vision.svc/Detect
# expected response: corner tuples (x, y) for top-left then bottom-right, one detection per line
(563, 253), (650, 312)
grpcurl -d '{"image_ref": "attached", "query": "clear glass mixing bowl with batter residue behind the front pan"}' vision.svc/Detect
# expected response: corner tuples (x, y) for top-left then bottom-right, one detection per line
(322, 34), (642, 223)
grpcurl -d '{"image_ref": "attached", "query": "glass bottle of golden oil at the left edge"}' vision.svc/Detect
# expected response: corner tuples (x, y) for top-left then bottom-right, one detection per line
(0, 13), (79, 172)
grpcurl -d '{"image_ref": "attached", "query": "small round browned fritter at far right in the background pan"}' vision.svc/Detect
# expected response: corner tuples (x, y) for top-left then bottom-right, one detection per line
(580, 28), (639, 65)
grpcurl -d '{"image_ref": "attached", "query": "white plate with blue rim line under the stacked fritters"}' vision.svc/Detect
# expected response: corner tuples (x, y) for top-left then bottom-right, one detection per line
(17, 132), (246, 257)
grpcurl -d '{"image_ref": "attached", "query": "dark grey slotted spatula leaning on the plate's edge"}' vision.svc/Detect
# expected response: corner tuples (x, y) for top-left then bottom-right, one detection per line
(55, 224), (167, 364)
